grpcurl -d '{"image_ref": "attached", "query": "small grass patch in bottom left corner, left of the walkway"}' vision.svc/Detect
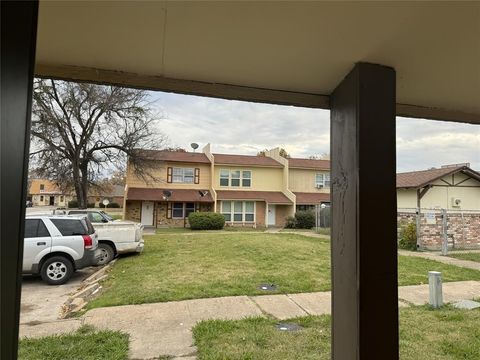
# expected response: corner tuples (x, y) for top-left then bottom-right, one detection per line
(18, 326), (128, 360)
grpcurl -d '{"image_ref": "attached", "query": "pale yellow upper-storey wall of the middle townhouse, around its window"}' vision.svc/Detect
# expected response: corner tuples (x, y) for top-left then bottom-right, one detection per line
(213, 165), (283, 191)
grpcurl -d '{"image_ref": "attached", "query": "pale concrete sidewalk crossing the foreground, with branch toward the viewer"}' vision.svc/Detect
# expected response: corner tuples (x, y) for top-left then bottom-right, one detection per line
(20, 281), (480, 360)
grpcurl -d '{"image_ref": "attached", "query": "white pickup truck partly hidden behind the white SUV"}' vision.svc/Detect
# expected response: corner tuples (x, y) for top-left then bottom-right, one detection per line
(55, 209), (144, 265)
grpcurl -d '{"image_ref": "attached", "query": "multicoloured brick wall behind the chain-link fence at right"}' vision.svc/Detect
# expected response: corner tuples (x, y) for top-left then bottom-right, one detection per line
(397, 210), (480, 250)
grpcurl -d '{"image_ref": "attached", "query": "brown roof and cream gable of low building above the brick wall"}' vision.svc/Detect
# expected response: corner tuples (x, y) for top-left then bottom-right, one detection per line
(397, 164), (480, 210)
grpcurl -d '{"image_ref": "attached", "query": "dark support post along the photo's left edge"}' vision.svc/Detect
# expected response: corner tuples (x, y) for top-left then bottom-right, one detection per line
(0, 1), (38, 360)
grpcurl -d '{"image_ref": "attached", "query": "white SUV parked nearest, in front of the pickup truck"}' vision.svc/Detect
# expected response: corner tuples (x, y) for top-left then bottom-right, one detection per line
(22, 215), (99, 285)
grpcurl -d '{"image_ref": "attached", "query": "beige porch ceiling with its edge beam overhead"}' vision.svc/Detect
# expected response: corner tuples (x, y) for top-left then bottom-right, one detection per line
(36, 0), (480, 123)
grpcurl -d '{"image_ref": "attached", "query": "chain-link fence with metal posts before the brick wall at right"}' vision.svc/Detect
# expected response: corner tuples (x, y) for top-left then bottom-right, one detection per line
(397, 209), (480, 254)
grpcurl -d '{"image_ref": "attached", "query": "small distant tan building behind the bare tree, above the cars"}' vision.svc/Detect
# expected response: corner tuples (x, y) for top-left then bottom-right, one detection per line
(27, 179), (74, 207)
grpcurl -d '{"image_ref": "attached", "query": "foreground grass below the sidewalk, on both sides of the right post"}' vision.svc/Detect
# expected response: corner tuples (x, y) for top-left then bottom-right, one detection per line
(193, 306), (480, 360)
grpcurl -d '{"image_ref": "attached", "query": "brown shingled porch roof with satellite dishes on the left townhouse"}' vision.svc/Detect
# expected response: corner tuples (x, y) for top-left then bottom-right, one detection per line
(126, 188), (213, 203)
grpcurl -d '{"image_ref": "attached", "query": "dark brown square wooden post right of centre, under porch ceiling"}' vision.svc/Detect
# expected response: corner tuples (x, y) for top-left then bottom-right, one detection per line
(331, 63), (399, 360)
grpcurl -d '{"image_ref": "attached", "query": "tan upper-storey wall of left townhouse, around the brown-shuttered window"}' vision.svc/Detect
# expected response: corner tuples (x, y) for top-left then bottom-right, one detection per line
(126, 162), (211, 189)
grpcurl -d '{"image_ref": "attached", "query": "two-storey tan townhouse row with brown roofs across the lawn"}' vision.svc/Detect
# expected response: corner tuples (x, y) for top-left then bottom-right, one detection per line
(124, 145), (330, 226)
